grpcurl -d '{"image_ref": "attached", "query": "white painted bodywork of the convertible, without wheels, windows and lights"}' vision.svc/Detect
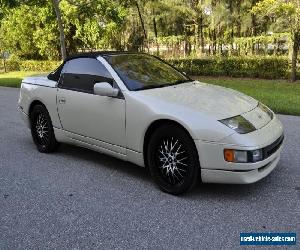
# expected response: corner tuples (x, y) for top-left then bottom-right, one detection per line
(19, 57), (283, 186)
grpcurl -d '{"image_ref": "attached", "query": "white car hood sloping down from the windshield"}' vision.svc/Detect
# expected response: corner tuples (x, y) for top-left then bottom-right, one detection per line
(139, 81), (258, 120)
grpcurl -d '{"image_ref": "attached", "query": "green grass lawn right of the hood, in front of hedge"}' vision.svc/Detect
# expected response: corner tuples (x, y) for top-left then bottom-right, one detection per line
(193, 76), (300, 115)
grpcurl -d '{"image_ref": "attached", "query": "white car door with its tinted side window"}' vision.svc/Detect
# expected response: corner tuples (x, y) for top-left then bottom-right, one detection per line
(57, 58), (126, 154)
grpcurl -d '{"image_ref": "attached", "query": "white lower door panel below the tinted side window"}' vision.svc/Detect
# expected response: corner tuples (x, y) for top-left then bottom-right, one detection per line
(57, 89), (126, 154)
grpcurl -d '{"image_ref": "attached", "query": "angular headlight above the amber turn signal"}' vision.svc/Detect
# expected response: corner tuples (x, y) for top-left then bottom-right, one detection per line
(220, 115), (255, 134)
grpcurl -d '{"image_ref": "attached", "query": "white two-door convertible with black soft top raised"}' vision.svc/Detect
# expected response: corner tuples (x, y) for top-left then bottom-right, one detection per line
(19, 52), (283, 194)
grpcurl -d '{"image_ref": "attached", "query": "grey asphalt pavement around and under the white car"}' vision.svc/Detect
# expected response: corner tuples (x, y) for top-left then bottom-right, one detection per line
(0, 88), (300, 249)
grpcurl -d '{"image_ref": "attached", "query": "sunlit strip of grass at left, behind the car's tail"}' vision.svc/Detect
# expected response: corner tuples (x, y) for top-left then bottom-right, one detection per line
(0, 71), (45, 88)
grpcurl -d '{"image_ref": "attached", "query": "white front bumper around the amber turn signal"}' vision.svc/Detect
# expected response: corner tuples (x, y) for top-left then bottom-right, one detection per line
(195, 117), (283, 184)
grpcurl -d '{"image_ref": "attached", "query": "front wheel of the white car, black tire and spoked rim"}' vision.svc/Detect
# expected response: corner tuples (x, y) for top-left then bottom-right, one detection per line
(147, 124), (200, 195)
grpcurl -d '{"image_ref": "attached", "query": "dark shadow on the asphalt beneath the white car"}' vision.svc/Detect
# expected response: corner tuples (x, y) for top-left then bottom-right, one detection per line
(51, 144), (272, 200)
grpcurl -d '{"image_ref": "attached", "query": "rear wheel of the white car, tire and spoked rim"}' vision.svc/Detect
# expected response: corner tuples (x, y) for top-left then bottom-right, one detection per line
(30, 104), (59, 153)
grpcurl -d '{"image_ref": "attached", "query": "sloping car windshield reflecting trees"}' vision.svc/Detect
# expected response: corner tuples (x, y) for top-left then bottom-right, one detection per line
(105, 54), (191, 91)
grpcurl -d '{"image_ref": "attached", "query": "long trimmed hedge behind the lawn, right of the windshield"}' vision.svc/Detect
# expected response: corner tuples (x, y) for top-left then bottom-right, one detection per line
(168, 57), (289, 79)
